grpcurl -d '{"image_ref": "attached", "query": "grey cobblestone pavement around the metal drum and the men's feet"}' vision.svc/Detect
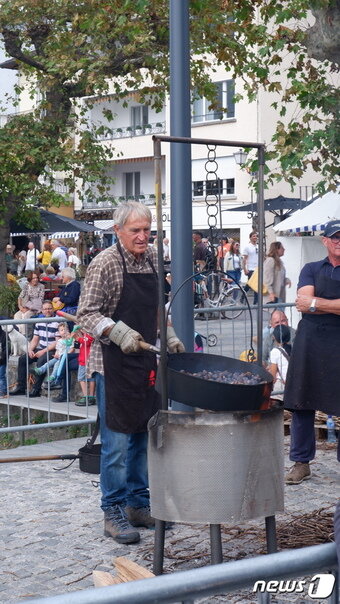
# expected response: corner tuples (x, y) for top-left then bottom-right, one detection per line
(0, 438), (340, 603)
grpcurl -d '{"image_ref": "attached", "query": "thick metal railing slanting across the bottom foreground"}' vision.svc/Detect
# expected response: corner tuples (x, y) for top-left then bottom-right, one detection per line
(22, 543), (340, 604)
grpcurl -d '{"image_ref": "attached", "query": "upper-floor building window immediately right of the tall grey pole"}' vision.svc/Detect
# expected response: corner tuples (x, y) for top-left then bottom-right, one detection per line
(192, 80), (235, 123)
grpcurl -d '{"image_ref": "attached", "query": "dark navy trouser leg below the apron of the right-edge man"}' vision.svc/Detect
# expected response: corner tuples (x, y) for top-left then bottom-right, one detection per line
(290, 410), (315, 463)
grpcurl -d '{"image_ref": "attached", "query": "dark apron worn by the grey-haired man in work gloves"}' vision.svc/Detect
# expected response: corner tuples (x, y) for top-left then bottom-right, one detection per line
(102, 244), (160, 434)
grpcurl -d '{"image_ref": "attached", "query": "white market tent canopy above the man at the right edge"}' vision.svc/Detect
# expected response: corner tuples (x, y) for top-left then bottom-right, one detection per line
(273, 187), (340, 233)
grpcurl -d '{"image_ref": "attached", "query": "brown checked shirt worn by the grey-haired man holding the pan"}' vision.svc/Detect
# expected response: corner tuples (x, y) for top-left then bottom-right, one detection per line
(77, 244), (157, 376)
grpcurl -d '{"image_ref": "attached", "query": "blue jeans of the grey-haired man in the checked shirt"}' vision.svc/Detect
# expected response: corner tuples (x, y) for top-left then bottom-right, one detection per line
(94, 372), (149, 510)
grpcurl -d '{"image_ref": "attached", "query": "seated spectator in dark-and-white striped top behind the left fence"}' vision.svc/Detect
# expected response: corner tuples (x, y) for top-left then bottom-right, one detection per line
(10, 300), (58, 396)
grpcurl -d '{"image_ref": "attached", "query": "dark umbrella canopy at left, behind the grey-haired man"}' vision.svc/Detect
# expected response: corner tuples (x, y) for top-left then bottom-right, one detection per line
(10, 209), (102, 239)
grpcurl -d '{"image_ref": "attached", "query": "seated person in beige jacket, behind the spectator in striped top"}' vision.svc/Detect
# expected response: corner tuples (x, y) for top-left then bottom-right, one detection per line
(14, 271), (45, 335)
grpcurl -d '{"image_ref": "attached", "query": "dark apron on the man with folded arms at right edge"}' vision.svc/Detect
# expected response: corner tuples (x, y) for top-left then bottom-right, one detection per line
(284, 268), (340, 415)
